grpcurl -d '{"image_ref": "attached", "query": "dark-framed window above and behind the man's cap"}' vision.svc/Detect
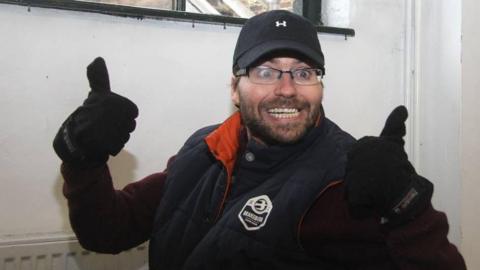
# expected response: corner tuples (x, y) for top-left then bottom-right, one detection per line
(0, 0), (355, 37)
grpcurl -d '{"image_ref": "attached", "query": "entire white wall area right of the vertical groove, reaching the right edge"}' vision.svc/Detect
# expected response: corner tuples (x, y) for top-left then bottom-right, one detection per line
(415, 0), (480, 269)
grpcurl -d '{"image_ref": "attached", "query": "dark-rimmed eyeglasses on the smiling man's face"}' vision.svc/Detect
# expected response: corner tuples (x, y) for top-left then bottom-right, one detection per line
(235, 66), (323, 85)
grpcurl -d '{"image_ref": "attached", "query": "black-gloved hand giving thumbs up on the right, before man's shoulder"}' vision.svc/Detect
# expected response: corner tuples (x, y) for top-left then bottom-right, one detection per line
(345, 106), (433, 226)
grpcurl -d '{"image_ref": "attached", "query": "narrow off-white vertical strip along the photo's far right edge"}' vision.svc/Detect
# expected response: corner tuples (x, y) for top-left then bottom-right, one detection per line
(461, 0), (480, 269)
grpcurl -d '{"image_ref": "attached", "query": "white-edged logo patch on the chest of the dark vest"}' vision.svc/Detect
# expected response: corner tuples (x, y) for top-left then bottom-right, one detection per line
(238, 195), (273, 231)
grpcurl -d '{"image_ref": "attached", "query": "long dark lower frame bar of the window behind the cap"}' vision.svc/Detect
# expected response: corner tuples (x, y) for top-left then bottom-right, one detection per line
(0, 0), (355, 39)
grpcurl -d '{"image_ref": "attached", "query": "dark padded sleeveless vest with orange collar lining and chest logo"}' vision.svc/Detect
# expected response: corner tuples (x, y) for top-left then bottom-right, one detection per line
(149, 113), (354, 270)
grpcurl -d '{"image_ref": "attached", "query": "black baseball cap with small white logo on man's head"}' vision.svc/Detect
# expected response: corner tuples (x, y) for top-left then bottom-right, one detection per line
(233, 10), (325, 73)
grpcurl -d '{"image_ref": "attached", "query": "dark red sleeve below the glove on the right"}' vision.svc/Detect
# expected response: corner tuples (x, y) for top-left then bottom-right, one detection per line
(299, 183), (466, 270)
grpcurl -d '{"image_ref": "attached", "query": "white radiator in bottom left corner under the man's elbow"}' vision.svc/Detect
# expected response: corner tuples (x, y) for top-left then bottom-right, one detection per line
(0, 236), (148, 270)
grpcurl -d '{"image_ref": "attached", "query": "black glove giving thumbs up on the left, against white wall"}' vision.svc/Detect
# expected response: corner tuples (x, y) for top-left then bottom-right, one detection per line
(53, 57), (138, 168)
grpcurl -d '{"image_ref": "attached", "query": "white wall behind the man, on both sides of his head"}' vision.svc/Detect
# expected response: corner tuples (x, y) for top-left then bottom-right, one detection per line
(0, 0), (460, 255)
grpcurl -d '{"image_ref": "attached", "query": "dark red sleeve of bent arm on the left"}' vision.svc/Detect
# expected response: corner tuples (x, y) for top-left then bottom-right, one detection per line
(61, 158), (171, 253)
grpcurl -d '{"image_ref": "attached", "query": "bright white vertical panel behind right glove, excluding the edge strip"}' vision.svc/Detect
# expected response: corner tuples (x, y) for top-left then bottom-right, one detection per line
(415, 0), (462, 247)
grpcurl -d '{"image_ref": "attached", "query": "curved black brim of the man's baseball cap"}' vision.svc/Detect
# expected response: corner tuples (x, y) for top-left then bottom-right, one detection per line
(237, 40), (324, 68)
